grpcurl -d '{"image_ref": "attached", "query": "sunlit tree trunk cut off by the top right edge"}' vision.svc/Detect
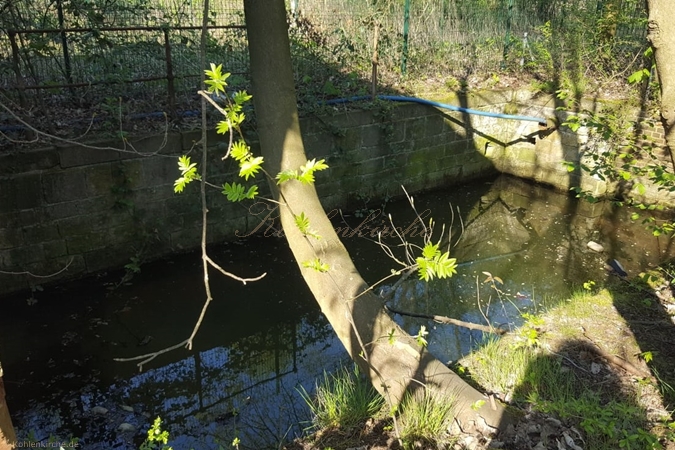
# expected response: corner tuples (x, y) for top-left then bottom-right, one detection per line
(647, 0), (675, 155)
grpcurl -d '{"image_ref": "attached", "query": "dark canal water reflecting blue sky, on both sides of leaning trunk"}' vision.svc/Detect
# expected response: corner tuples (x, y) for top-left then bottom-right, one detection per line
(0, 176), (672, 450)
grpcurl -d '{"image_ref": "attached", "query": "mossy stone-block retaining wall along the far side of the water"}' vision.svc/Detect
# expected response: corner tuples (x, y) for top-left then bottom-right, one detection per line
(0, 92), (672, 295)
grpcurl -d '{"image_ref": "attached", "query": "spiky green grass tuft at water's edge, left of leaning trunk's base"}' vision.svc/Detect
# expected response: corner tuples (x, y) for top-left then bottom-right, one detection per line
(300, 366), (384, 431)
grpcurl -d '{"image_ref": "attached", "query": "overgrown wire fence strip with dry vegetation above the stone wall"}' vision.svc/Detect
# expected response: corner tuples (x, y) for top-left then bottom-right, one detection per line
(0, 0), (646, 139)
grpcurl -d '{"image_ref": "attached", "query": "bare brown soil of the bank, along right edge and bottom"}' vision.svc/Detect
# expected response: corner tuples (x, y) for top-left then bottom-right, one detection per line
(284, 272), (675, 450)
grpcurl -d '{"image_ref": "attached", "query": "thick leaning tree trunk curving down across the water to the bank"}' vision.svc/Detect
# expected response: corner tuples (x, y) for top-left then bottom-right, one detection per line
(244, 0), (511, 431)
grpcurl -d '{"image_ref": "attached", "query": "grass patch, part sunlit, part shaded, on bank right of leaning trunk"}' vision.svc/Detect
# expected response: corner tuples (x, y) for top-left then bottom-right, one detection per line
(461, 290), (662, 450)
